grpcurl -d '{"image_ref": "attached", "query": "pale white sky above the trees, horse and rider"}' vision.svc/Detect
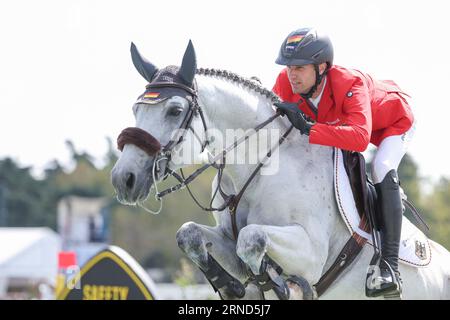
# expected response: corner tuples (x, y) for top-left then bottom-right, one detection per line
(0, 0), (450, 180)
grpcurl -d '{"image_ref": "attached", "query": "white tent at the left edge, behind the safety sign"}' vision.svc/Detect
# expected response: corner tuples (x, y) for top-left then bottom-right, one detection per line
(0, 228), (61, 297)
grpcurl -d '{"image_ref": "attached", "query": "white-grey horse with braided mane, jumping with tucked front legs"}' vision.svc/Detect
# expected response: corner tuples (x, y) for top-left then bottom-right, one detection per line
(112, 41), (450, 299)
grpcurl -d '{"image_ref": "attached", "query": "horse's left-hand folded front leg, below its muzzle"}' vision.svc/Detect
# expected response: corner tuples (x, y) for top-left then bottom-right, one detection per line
(177, 222), (260, 299)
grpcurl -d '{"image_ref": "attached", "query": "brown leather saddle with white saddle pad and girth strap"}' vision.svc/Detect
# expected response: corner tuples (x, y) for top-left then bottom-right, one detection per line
(314, 148), (431, 296)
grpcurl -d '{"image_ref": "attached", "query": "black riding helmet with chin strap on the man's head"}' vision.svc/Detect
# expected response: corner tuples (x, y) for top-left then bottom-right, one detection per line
(275, 28), (334, 99)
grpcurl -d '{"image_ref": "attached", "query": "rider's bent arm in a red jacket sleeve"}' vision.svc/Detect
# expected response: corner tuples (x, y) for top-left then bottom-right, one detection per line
(309, 79), (372, 152)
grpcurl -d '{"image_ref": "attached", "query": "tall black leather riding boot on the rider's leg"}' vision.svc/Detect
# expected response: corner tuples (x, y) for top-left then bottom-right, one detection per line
(371, 169), (403, 297)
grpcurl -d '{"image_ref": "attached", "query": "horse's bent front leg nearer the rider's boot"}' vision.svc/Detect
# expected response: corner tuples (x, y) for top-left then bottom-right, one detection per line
(237, 224), (328, 299)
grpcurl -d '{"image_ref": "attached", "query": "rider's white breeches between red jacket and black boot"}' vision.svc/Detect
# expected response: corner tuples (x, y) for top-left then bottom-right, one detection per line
(372, 122), (416, 183)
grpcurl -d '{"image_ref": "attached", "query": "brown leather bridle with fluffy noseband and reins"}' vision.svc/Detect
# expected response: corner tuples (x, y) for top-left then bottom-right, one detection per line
(117, 77), (293, 240)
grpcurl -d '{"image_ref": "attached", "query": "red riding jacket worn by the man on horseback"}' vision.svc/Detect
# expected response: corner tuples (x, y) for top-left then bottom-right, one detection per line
(272, 66), (414, 152)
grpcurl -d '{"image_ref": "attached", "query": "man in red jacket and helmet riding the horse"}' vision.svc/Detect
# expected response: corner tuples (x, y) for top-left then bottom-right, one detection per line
(273, 28), (414, 296)
